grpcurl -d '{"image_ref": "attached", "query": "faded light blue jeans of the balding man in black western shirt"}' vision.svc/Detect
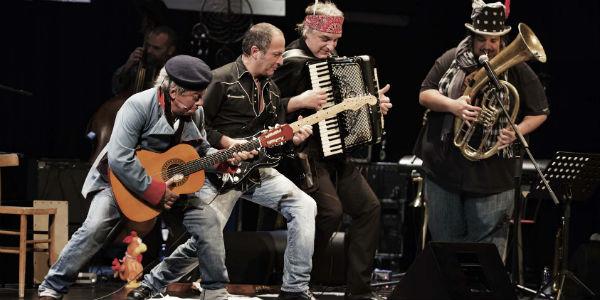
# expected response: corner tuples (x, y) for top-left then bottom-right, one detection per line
(198, 168), (317, 292)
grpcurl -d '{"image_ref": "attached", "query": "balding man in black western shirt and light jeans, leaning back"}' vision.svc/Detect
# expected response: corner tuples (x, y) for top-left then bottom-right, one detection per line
(200, 23), (316, 300)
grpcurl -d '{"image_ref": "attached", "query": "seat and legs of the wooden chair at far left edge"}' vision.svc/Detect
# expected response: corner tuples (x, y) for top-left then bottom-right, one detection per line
(0, 206), (56, 298)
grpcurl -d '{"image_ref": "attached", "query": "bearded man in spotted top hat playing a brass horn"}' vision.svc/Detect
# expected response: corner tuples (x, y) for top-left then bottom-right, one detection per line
(415, 0), (549, 256)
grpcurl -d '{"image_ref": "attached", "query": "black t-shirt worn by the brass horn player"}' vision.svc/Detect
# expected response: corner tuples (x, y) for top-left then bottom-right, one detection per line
(419, 49), (549, 194)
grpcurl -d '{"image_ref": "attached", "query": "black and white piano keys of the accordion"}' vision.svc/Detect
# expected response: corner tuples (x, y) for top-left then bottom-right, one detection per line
(308, 61), (344, 157)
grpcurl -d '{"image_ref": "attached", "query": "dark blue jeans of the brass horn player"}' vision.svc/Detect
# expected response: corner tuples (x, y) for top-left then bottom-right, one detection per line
(424, 178), (514, 259)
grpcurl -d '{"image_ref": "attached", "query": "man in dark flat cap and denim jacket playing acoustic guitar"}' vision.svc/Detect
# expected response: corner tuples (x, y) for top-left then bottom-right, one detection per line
(38, 55), (252, 299)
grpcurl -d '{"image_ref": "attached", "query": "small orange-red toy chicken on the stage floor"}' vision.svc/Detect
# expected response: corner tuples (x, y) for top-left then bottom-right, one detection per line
(112, 231), (146, 288)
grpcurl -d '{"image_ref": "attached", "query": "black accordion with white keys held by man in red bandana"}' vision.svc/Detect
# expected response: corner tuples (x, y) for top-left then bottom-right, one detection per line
(307, 55), (383, 157)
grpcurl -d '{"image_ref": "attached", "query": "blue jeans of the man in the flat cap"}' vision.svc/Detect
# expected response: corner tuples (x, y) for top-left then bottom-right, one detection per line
(38, 188), (227, 298)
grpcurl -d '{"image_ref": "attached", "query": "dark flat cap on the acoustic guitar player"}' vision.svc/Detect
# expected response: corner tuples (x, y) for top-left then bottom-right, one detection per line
(165, 55), (212, 91)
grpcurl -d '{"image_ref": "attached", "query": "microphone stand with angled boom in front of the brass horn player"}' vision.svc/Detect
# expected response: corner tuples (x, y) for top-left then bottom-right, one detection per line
(479, 55), (559, 296)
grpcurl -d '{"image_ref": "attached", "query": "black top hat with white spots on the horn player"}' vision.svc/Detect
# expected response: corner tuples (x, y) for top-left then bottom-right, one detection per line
(465, 1), (510, 36)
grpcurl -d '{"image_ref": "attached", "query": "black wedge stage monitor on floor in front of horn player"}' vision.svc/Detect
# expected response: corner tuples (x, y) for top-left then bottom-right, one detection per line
(390, 242), (517, 300)
